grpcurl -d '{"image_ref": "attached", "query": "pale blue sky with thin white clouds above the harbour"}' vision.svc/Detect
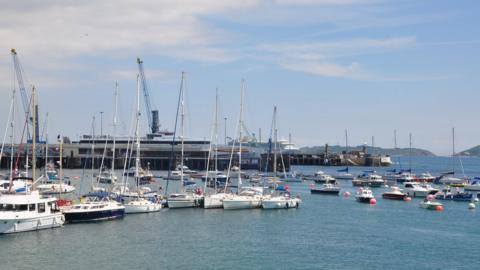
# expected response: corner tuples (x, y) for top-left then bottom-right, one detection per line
(0, 0), (480, 155)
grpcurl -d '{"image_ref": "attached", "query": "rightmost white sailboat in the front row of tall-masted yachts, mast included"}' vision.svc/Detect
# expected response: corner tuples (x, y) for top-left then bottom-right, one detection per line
(262, 106), (301, 209)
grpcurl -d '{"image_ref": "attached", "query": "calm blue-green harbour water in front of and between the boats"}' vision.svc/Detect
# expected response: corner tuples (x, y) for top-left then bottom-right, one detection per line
(0, 158), (480, 269)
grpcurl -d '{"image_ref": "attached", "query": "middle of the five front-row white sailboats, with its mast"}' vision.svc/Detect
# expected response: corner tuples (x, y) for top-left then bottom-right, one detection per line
(202, 90), (231, 209)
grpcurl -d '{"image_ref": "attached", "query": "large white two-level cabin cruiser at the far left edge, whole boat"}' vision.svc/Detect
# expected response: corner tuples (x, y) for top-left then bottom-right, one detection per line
(0, 190), (65, 234)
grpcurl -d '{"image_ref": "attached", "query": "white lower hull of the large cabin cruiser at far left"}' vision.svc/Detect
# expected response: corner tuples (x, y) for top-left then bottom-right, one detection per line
(0, 213), (65, 234)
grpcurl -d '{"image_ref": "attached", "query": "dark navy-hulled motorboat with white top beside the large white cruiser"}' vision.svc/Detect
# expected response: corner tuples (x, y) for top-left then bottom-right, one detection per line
(62, 192), (125, 223)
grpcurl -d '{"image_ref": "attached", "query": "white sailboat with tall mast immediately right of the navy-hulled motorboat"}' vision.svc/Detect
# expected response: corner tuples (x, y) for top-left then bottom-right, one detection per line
(124, 76), (162, 214)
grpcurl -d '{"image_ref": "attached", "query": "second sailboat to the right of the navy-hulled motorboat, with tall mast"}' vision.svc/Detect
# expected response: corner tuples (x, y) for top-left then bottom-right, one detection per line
(167, 72), (203, 208)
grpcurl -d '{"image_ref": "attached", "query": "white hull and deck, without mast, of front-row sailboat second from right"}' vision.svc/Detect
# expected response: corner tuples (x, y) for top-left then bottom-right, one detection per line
(223, 187), (263, 210)
